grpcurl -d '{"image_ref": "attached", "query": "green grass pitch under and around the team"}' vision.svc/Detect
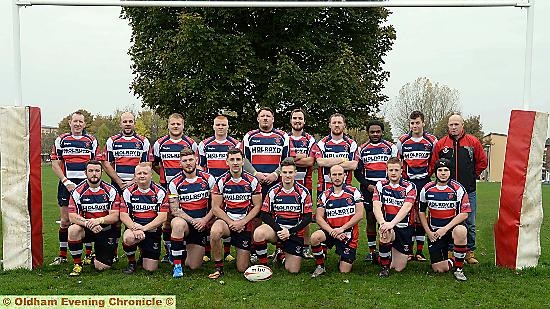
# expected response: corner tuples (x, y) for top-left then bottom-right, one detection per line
(0, 167), (550, 308)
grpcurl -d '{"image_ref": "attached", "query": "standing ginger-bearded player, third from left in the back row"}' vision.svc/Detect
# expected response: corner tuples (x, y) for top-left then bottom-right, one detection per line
(153, 113), (198, 262)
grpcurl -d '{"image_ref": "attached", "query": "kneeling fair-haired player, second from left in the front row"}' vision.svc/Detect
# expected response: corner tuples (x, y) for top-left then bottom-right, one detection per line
(120, 162), (169, 274)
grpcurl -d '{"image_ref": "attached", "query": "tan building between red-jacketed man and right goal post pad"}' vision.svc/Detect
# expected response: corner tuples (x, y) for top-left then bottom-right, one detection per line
(481, 133), (507, 182)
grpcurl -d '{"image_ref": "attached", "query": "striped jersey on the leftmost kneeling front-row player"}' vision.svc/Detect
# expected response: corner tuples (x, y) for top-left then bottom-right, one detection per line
(69, 180), (120, 219)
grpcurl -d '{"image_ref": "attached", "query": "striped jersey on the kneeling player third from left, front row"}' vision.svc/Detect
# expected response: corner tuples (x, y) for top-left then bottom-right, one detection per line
(168, 170), (216, 219)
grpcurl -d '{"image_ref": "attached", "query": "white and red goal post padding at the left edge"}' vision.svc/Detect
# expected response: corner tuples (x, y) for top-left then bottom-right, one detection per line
(0, 106), (44, 270)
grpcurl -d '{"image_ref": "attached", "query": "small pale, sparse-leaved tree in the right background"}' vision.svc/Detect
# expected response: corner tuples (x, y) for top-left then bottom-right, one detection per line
(391, 77), (460, 134)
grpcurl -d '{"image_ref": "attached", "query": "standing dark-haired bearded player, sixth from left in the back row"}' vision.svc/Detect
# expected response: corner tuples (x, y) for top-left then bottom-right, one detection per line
(288, 109), (315, 259)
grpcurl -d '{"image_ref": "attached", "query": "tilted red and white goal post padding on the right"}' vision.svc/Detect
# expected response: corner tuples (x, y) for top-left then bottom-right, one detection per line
(494, 110), (548, 269)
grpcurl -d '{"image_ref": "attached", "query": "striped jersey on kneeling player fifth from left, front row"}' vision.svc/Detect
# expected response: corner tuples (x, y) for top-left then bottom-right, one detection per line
(262, 183), (313, 237)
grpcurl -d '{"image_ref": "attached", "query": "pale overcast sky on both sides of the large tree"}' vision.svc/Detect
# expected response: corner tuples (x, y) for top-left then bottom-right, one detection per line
(0, 0), (550, 133)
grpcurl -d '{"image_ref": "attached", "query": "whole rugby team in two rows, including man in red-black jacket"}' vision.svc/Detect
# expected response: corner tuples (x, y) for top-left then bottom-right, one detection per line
(50, 107), (487, 281)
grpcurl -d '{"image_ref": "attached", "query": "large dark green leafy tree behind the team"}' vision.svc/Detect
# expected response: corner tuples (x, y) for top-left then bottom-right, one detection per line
(122, 8), (395, 136)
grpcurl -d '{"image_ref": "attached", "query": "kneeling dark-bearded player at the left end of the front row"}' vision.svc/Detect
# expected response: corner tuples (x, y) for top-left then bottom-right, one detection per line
(69, 160), (120, 276)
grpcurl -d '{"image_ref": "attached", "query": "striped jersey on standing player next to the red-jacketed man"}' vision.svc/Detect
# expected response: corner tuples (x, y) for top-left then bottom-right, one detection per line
(397, 132), (437, 179)
